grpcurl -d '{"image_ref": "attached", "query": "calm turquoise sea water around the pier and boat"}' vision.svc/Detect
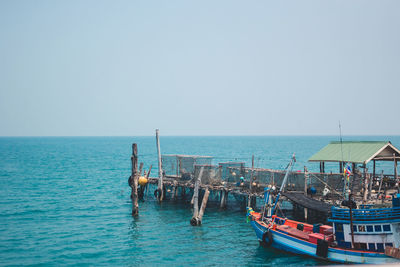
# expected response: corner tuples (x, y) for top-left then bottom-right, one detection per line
(0, 136), (400, 266)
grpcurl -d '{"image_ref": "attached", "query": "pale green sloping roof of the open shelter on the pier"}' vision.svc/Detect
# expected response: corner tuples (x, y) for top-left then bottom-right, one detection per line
(308, 141), (400, 164)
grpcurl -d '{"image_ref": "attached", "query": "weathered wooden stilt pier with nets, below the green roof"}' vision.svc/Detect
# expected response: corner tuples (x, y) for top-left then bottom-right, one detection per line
(128, 133), (398, 226)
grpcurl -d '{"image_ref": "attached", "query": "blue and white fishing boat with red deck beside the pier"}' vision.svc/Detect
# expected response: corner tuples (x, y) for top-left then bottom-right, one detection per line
(247, 156), (400, 264)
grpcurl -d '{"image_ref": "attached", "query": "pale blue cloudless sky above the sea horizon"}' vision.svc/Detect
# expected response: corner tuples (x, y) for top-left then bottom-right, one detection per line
(0, 0), (400, 136)
